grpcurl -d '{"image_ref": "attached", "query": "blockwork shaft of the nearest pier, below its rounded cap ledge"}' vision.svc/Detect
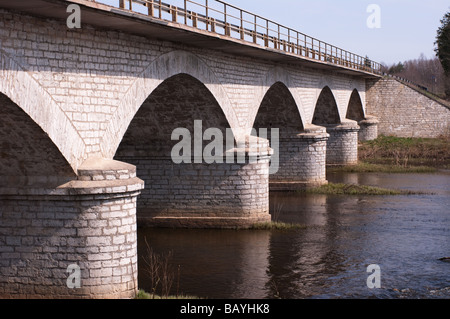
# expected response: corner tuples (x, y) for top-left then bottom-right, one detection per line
(0, 196), (137, 298)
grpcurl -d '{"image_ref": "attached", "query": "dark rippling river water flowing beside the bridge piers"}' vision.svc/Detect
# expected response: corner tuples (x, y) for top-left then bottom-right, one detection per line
(138, 171), (450, 299)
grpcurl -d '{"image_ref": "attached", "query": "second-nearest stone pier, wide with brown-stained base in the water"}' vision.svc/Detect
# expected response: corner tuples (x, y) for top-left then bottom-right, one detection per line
(116, 137), (272, 228)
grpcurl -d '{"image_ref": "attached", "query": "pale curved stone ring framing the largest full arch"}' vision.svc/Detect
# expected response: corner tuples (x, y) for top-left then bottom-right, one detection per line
(101, 51), (239, 158)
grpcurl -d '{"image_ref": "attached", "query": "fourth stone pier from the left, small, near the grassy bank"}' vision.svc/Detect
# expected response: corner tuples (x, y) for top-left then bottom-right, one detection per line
(324, 120), (360, 165)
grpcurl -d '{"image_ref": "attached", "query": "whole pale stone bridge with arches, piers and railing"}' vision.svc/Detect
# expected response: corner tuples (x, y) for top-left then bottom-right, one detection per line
(0, 0), (379, 298)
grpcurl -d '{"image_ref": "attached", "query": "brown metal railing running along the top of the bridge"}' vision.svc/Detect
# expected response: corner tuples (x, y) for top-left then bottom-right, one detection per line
(91, 0), (381, 74)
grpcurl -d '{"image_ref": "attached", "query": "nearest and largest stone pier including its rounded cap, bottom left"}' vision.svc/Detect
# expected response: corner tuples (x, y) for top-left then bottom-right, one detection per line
(0, 160), (143, 298)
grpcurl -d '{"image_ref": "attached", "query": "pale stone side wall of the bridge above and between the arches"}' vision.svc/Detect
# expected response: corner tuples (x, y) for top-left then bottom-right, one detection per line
(0, 9), (365, 168)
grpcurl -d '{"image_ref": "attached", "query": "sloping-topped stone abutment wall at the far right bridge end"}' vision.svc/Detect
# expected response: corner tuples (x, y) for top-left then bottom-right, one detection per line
(366, 78), (450, 137)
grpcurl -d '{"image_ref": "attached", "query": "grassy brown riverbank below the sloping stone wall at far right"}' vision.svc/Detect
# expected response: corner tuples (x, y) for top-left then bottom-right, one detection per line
(328, 136), (450, 173)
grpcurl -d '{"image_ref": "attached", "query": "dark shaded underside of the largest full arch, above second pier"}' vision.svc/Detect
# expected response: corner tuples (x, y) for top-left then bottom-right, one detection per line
(115, 73), (234, 157)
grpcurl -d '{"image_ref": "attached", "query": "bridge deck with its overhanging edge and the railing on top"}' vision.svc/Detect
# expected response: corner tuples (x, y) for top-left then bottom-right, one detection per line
(0, 0), (381, 77)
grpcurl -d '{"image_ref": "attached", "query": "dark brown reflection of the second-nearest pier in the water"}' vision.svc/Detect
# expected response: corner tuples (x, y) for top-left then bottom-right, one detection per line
(139, 229), (272, 299)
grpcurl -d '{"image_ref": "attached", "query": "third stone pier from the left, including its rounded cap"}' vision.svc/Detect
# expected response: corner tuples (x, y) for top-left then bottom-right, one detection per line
(270, 125), (329, 191)
